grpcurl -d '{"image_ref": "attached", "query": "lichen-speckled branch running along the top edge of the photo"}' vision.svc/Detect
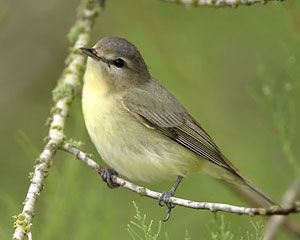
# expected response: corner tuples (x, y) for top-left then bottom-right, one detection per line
(162, 0), (284, 7)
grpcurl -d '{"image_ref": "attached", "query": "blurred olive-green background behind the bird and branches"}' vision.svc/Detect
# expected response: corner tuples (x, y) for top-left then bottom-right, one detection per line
(0, 0), (300, 240)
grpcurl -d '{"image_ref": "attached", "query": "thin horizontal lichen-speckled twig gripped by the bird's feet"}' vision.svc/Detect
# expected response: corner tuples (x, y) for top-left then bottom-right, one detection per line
(62, 143), (300, 216)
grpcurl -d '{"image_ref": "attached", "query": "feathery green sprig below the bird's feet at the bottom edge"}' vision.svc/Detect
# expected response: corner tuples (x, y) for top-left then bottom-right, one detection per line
(127, 202), (161, 240)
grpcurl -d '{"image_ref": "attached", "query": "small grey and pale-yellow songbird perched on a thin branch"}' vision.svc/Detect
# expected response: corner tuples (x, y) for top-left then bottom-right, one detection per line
(81, 37), (272, 219)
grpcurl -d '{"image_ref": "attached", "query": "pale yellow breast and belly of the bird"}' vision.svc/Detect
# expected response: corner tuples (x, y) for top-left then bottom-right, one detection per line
(82, 92), (204, 182)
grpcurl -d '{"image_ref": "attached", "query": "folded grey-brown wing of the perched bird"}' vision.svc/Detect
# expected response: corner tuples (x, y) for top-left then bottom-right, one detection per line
(122, 89), (240, 177)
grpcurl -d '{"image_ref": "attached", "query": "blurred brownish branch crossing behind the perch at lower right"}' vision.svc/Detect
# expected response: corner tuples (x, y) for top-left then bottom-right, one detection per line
(264, 178), (300, 240)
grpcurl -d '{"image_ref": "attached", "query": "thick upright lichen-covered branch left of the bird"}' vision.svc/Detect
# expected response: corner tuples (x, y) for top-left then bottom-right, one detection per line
(13, 0), (104, 240)
